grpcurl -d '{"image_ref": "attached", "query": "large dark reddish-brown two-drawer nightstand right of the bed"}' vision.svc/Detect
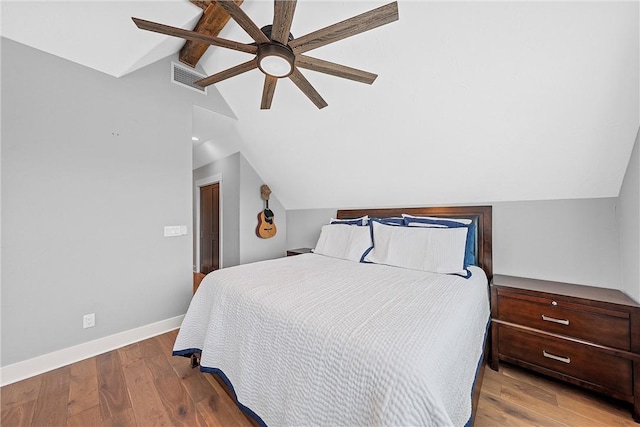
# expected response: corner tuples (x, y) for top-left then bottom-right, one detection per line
(491, 274), (640, 422)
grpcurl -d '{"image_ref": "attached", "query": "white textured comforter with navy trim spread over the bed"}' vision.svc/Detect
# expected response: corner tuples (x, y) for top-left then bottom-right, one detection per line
(174, 254), (489, 426)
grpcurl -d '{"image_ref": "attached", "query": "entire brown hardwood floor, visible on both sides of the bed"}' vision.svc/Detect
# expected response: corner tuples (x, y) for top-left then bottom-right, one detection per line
(0, 331), (639, 427)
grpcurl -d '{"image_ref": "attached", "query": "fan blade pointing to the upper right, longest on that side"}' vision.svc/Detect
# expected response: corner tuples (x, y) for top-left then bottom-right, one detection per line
(289, 2), (398, 55)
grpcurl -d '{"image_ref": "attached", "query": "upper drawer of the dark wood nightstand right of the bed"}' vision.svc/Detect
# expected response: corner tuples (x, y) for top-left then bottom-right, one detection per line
(498, 294), (631, 350)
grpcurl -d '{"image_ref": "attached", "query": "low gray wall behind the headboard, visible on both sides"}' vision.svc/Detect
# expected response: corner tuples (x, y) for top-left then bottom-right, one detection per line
(287, 198), (621, 289)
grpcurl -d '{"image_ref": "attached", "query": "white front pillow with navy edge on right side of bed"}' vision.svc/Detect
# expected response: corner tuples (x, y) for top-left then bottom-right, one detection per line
(364, 222), (467, 275)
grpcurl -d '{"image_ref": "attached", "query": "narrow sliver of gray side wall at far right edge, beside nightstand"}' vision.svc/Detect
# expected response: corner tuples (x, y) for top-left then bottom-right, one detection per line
(618, 130), (640, 302)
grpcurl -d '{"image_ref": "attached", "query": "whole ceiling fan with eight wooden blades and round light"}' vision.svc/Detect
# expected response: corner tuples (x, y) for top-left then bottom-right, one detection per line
(131, 0), (398, 109)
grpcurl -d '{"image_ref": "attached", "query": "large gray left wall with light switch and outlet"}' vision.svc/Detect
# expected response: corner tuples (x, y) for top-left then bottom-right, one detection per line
(0, 39), (229, 366)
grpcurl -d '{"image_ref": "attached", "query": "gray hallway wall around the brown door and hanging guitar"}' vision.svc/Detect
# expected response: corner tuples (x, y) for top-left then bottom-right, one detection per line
(193, 153), (287, 267)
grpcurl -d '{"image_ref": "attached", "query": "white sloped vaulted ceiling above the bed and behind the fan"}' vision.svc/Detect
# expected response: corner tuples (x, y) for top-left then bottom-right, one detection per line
(2, 0), (640, 209)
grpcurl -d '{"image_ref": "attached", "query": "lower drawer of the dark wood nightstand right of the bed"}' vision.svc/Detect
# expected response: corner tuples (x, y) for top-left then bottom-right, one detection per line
(498, 325), (633, 395)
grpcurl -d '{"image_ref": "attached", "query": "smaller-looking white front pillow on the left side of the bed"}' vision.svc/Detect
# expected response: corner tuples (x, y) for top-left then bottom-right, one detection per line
(313, 224), (372, 262)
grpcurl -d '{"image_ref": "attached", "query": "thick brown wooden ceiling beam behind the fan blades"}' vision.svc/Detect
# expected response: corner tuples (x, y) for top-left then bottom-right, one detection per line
(179, 0), (244, 68)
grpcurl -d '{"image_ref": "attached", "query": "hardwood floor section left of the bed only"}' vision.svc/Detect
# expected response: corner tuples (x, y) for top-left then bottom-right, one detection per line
(0, 331), (247, 427)
